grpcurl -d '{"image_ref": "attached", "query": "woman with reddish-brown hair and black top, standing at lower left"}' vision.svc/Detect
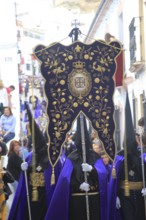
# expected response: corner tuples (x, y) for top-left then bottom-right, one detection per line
(7, 140), (23, 190)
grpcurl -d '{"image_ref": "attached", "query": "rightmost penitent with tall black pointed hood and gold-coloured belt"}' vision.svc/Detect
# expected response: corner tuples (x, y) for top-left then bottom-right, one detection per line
(109, 93), (146, 220)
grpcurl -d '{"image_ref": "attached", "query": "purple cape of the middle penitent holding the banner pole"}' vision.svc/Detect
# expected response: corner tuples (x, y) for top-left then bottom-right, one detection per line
(45, 159), (108, 220)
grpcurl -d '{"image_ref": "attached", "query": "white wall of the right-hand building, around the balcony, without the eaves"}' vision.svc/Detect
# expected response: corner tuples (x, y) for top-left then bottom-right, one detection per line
(88, 0), (146, 146)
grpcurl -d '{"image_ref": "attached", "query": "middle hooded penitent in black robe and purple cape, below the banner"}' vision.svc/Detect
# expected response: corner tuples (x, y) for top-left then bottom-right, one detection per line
(45, 118), (108, 220)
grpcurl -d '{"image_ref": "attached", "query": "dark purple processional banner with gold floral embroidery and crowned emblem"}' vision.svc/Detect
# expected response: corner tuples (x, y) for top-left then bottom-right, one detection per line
(34, 41), (121, 167)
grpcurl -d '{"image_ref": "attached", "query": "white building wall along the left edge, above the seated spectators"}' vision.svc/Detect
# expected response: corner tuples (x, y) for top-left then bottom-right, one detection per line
(0, 0), (20, 138)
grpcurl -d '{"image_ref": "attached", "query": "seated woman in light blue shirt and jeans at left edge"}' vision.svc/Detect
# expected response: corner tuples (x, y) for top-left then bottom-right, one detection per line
(0, 107), (16, 143)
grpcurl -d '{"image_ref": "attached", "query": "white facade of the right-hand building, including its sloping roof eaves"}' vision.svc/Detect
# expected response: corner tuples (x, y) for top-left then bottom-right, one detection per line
(86, 0), (146, 147)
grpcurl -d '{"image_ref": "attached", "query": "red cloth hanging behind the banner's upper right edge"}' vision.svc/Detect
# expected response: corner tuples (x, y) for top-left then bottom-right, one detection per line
(114, 51), (124, 87)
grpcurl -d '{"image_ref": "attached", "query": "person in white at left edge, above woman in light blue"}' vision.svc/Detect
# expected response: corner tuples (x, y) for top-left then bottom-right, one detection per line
(0, 80), (8, 115)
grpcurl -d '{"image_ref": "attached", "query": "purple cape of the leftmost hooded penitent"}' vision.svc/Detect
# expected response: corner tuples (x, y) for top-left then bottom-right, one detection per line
(8, 153), (61, 220)
